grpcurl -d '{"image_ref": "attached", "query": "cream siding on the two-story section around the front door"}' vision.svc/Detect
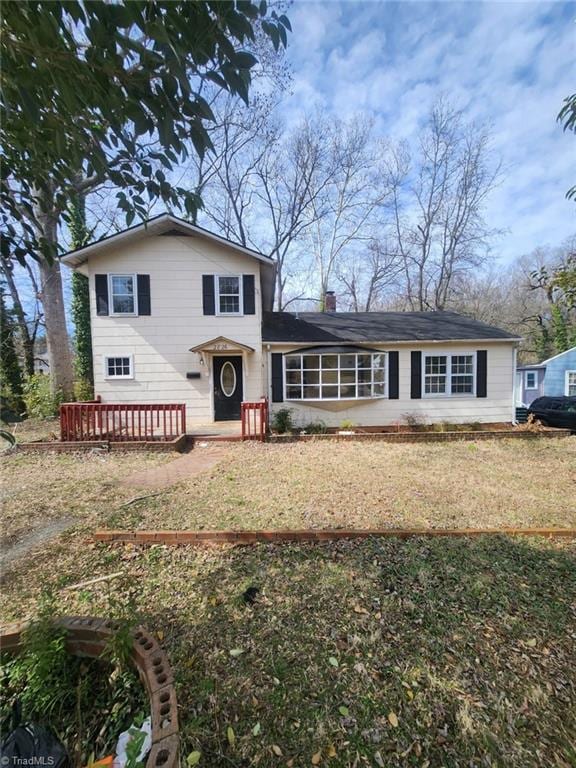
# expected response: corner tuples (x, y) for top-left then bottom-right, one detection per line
(87, 235), (264, 426)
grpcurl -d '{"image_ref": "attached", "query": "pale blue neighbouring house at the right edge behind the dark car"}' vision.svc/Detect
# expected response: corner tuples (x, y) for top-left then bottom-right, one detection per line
(516, 347), (576, 408)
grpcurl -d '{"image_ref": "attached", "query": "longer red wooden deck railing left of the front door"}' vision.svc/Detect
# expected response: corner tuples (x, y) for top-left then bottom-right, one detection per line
(60, 402), (186, 442)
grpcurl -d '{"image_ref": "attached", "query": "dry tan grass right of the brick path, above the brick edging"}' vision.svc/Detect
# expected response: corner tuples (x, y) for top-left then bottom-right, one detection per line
(127, 439), (576, 529)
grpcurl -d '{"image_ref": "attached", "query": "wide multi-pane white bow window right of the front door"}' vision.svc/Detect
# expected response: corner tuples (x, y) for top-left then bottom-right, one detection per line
(284, 352), (386, 400)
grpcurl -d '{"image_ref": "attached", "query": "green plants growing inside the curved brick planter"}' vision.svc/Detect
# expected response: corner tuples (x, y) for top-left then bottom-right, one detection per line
(0, 592), (146, 766)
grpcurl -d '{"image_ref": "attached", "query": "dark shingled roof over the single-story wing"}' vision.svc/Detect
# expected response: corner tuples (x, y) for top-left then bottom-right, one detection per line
(262, 312), (518, 344)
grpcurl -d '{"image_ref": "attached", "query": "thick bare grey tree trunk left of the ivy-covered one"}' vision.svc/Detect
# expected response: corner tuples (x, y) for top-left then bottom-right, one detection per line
(36, 204), (74, 400)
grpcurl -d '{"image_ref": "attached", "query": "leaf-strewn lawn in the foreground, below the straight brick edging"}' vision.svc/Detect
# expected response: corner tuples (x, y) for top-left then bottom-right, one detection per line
(2, 534), (576, 768)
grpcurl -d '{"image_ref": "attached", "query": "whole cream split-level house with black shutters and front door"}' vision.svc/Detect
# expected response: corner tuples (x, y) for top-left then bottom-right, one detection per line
(62, 214), (519, 429)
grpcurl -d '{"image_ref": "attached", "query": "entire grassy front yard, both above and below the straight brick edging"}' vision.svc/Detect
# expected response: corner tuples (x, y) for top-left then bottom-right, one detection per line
(0, 439), (576, 768)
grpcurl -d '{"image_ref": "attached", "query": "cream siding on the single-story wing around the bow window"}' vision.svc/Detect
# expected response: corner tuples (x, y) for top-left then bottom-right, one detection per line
(267, 342), (514, 427)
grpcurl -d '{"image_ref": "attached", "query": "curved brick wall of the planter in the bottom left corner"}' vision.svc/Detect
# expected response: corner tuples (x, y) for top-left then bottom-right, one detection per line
(0, 616), (179, 768)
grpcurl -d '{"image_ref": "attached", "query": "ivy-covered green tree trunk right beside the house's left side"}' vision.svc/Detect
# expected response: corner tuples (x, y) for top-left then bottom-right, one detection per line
(69, 195), (94, 397)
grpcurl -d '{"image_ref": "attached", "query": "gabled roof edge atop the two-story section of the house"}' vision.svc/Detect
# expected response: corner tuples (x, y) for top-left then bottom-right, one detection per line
(61, 213), (274, 269)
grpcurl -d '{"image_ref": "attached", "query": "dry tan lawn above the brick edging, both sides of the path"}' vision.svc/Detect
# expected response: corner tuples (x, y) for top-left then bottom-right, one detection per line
(2, 439), (576, 540)
